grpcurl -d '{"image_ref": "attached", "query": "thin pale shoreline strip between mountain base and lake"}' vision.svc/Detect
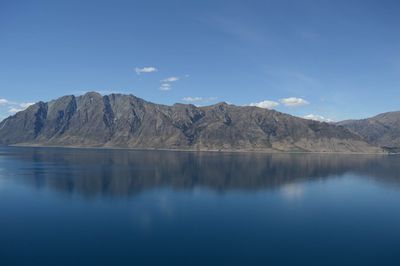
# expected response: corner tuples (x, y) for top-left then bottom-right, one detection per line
(3, 143), (394, 155)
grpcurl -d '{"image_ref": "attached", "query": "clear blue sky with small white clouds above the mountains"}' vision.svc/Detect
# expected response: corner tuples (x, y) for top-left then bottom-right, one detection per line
(0, 0), (400, 121)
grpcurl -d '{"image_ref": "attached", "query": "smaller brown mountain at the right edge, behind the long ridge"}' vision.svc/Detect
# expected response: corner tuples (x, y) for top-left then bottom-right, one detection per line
(337, 112), (400, 151)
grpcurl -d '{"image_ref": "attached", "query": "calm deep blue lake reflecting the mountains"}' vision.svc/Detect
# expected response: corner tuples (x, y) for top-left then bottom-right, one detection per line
(0, 147), (400, 265)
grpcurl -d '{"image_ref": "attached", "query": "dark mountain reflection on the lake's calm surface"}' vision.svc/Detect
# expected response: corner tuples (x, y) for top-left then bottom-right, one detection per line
(0, 145), (400, 197)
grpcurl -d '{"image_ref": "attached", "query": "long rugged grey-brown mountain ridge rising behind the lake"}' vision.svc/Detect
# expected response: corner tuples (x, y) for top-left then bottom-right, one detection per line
(0, 92), (382, 153)
